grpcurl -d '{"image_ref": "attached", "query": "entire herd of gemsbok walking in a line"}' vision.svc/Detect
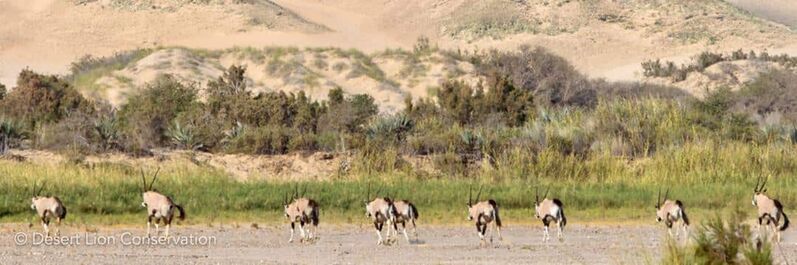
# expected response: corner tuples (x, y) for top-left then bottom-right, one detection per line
(30, 170), (789, 245)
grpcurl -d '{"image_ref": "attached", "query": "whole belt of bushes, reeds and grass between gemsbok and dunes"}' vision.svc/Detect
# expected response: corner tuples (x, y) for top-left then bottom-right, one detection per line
(0, 42), (797, 223)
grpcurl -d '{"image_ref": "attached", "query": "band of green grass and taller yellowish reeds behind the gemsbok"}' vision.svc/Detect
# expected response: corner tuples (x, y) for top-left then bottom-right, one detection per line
(0, 139), (797, 225)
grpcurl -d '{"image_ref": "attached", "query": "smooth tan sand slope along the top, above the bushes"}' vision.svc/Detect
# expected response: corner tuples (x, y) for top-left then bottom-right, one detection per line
(0, 0), (797, 86)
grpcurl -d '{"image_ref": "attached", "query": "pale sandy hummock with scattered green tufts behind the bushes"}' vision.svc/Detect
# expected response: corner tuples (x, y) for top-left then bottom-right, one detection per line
(72, 40), (481, 112)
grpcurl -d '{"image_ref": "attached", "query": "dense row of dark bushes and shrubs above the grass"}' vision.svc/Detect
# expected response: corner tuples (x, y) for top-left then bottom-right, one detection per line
(0, 45), (797, 179)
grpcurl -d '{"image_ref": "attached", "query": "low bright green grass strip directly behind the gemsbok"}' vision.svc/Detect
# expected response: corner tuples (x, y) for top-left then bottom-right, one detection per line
(0, 157), (797, 225)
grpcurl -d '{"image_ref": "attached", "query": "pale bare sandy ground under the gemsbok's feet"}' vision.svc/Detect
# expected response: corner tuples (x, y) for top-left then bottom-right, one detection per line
(0, 225), (797, 264)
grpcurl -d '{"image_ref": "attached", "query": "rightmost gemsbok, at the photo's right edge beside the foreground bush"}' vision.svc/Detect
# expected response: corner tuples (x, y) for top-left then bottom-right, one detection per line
(753, 177), (789, 242)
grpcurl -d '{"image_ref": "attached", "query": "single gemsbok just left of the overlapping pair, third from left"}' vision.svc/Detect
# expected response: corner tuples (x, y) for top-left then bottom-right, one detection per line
(283, 185), (320, 242)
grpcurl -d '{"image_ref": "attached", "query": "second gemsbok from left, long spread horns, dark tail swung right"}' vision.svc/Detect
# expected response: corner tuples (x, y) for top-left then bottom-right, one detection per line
(141, 168), (185, 237)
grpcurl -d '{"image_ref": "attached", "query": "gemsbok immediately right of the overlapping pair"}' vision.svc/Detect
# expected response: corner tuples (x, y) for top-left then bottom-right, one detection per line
(468, 187), (503, 245)
